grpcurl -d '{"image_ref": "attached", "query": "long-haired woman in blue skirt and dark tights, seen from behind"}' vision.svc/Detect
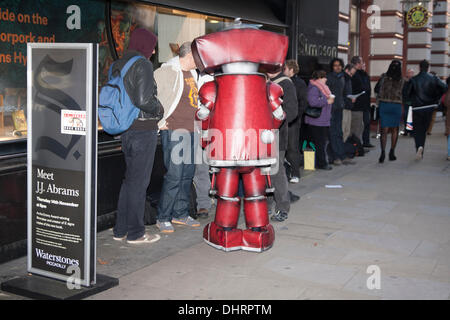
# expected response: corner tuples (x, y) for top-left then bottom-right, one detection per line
(375, 59), (404, 163)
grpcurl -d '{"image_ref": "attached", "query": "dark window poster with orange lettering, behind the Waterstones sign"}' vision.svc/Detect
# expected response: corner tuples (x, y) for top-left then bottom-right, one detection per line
(0, 0), (105, 88)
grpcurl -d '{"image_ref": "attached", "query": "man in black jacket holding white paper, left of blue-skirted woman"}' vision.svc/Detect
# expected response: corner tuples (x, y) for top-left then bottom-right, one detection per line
(351, 56), (374, 148)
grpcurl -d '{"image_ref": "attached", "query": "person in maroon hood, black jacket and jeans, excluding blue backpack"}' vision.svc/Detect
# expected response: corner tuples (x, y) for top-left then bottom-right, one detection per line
(112, 29), (164, 244)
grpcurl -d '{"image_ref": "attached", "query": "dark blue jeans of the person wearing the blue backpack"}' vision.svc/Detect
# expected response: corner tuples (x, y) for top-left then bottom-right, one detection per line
(114, 130), (158, 240)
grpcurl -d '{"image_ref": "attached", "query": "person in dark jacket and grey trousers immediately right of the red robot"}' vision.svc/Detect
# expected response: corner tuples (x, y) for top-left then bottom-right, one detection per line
(268, 70), (298, 221)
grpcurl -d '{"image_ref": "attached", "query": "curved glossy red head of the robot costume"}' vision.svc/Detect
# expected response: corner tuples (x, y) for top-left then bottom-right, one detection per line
(192, 29), (289, 72)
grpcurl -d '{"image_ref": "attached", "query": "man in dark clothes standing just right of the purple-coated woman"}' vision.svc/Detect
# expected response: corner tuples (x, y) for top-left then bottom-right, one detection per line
(327, 58), (355, 166)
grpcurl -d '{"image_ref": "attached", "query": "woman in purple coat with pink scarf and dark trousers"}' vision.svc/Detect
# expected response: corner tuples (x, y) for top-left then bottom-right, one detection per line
(305, 70), (334, 170)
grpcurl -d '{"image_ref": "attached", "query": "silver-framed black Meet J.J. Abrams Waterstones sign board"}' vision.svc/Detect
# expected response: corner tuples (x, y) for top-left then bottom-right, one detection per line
(27, 43), (98, 286)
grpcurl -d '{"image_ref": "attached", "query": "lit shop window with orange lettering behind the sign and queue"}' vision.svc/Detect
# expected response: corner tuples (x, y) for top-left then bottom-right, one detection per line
(0, 0), (237, 148)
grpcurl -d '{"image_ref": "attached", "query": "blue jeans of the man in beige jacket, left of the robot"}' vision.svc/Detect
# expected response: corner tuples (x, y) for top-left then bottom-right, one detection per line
(158, 130), (195, 222)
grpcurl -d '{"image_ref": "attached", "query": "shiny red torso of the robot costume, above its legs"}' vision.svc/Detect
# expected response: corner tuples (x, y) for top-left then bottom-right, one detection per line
(207, 74), (276, 161)
